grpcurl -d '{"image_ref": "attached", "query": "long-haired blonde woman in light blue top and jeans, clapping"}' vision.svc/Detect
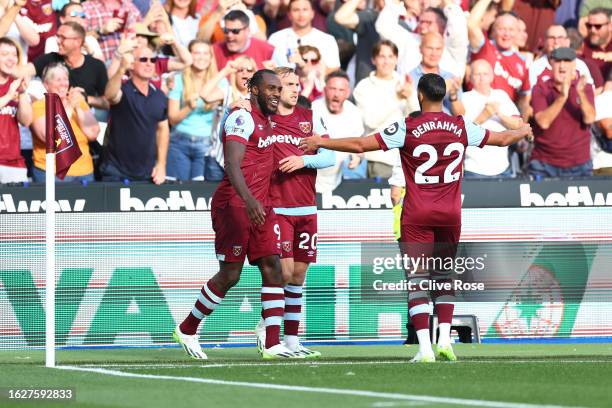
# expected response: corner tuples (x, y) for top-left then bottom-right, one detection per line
(167, 40), (231, 181)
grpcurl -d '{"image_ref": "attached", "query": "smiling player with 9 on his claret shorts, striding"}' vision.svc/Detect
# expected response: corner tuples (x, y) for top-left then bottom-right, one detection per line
(174, 70), (302, 359)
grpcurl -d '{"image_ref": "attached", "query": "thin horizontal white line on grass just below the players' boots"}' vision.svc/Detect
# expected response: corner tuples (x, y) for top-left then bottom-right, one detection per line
(79, 358), (612, 370)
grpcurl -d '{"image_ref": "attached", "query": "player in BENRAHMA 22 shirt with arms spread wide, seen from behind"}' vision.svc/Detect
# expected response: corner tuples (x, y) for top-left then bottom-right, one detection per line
(300, 74), (533, 362)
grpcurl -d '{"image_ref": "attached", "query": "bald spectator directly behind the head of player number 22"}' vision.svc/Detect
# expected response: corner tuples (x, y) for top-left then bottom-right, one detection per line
(409, 31), (465, 115)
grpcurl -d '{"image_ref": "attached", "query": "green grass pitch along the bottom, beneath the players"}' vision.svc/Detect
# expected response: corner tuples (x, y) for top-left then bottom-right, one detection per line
(0, 344), (612, 408)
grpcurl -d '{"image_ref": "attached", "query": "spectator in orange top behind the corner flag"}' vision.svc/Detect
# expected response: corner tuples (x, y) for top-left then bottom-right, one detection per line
(32, 63), (100, 183)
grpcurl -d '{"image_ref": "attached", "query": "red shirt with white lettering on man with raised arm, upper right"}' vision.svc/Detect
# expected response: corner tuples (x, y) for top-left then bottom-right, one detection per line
(472, 36), (531, 102)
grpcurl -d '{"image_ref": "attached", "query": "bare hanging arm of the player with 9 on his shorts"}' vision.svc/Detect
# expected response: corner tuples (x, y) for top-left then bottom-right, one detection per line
(225, 140), (266, 225)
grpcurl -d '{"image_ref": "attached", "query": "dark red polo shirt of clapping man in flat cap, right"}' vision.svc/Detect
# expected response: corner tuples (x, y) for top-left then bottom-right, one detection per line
(531, 77), (595, 168)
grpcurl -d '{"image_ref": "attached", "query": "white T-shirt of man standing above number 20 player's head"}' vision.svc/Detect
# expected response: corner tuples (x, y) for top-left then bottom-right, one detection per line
(268, 27), (340, 68)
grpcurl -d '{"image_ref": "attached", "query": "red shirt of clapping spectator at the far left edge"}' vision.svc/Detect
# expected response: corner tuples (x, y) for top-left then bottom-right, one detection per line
(0, 79), (25, 168)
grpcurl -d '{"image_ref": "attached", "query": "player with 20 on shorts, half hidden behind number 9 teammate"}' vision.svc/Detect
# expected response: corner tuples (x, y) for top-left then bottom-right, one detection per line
(255, 68), (336, 358)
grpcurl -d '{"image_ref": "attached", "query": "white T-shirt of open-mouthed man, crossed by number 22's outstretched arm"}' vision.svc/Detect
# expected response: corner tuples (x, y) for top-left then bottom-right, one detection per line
(312, 98), (364, 193)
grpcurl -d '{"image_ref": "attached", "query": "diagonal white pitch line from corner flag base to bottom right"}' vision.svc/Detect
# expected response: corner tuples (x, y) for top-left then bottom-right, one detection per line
(56, 366), (584, 408)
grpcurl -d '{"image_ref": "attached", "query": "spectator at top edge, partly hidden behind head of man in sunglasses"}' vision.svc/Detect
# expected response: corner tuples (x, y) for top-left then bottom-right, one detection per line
(197, 0), (267, 43)
